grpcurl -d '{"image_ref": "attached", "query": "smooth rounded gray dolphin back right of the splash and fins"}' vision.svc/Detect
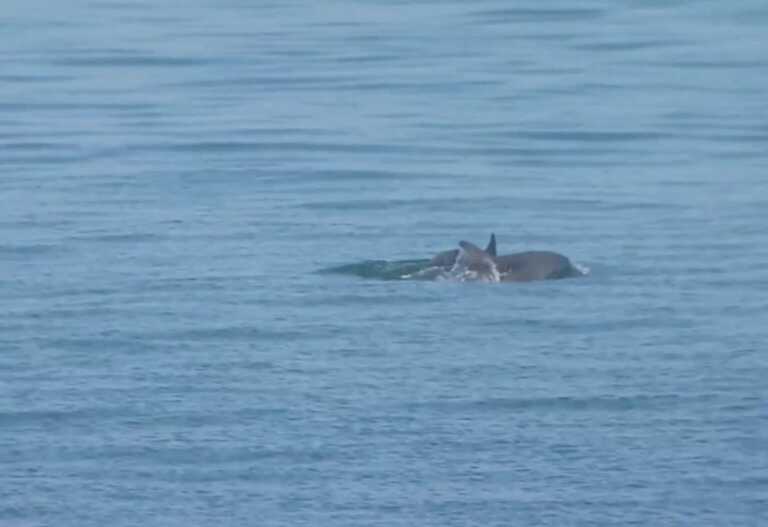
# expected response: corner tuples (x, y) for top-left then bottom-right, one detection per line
(496, 251), (581, 282)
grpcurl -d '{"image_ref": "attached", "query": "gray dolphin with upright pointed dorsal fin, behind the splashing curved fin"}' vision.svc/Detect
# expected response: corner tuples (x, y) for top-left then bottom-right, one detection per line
(430, 234), (583, 282)
